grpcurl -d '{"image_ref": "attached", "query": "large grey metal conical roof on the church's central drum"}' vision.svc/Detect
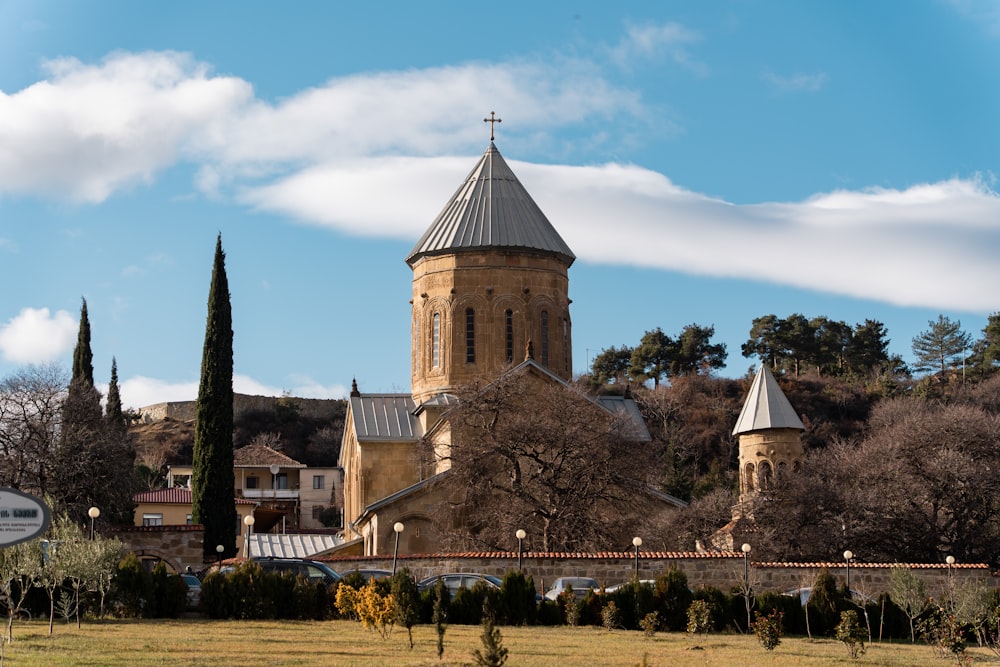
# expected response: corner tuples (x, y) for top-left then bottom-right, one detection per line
(406, 141), (576, 267)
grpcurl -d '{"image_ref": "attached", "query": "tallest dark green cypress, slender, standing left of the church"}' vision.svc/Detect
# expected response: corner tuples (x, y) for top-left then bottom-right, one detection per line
(191, 234), (237, 558)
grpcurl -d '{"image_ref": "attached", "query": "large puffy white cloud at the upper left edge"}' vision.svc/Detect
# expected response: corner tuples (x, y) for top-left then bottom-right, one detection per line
(0, 52), (251, 203)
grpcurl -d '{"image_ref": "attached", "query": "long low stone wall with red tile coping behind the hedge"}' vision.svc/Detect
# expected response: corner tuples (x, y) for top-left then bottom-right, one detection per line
(324, 551), (1000, 598)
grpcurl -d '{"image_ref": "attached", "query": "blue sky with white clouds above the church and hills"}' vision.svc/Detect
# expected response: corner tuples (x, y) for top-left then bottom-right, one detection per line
(0, 0), (1000, 407)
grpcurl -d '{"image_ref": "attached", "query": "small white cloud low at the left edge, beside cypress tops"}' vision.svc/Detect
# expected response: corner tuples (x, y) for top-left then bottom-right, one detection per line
(0, 308), (79, 364)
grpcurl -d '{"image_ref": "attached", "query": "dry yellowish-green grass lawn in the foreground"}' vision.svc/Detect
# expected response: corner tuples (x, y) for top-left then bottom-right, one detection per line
(2, 619), (1000, 667)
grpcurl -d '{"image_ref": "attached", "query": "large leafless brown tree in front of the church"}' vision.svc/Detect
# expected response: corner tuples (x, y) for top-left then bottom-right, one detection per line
(423, 371), (655, 551)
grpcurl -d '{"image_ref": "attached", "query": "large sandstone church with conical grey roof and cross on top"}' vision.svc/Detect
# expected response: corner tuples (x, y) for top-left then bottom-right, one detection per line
(338, 119), (684, 555)
